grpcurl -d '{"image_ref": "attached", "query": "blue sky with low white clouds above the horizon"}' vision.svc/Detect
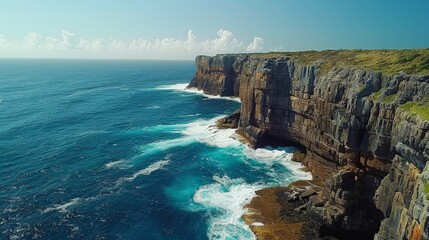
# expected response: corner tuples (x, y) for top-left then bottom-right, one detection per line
(0, 0), (429, 60)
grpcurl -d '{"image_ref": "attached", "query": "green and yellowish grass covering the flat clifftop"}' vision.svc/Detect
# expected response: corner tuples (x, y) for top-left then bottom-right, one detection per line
(253, 48), (429, 75)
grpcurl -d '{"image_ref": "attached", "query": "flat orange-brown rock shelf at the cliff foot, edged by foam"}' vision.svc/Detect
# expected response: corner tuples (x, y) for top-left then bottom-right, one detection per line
(239, 152), (368, 240)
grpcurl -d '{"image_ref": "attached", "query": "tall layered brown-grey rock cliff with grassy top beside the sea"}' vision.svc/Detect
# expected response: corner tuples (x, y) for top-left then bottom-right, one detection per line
(189, 49), (429, 239)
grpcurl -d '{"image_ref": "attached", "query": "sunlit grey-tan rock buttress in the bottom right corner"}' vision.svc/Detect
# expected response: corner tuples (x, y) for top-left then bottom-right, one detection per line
(374, 158), (429, 240)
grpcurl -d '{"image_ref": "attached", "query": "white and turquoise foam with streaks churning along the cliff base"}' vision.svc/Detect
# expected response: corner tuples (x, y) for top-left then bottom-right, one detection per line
(132, 113), (311, 239)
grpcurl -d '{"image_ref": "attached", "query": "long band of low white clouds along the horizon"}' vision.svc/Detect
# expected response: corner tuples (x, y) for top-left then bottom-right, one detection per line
(0, 29), (264, 57)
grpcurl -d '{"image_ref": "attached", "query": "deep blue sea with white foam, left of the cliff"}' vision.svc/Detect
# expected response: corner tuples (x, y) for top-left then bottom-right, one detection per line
(0, 59), (309, 239)
